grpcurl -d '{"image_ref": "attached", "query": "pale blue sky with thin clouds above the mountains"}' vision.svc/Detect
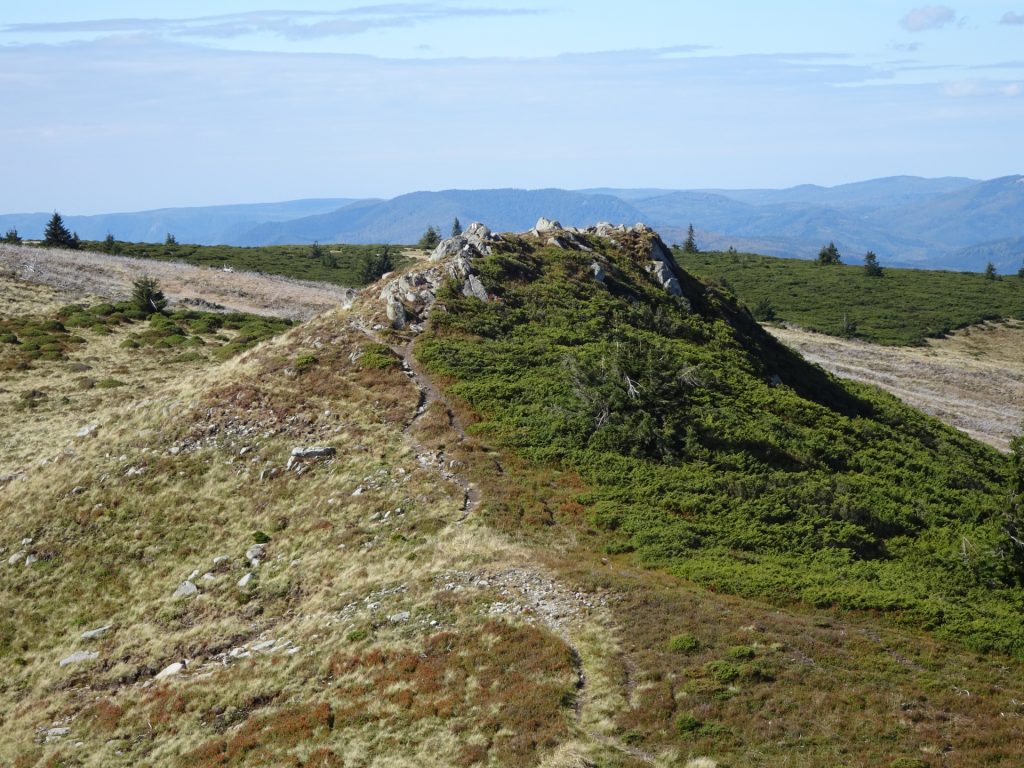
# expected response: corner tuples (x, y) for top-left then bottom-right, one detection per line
(0, 0), (1024, 214)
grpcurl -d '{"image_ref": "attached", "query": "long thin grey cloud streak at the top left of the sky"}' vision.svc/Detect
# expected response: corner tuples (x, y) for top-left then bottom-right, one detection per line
(0, 3), (546, 40)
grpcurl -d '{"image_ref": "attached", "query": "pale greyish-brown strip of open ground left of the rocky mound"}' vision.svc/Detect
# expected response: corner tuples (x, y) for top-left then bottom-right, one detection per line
(0, 245), (354, 321)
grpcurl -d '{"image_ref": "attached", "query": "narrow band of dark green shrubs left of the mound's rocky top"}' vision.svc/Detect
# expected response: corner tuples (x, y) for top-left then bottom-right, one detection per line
(82, 241), (409, 286)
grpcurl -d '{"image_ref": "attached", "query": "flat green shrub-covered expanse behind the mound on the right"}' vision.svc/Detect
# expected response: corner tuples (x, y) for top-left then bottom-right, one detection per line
(677, 252), (1024, 344)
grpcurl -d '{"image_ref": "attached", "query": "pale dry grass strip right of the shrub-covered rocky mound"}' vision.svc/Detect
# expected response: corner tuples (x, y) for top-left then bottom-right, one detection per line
(769, 324), (1024, 451)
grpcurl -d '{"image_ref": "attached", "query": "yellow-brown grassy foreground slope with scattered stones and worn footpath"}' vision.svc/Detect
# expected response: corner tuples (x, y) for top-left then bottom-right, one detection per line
(6, 249), (1024, 768)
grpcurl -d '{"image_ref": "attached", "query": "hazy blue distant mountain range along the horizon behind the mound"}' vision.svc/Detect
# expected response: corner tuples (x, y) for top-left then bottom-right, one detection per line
(0, 176), (1024, 272)
